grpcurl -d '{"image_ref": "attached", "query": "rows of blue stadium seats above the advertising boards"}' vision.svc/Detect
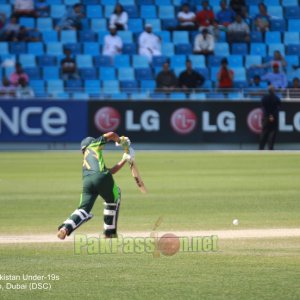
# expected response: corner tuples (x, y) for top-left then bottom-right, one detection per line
(0, 0), (300, 101)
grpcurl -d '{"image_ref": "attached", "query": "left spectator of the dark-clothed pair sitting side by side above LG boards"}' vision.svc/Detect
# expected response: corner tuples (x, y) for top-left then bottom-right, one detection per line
(156, 62), (177, 93)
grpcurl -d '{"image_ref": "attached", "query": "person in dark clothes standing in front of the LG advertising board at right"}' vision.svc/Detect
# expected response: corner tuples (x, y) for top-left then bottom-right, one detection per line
(259, 85), (281, 150)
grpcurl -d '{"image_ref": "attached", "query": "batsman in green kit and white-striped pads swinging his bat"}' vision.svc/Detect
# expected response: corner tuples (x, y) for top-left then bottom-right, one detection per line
(57, 132), (134, 240)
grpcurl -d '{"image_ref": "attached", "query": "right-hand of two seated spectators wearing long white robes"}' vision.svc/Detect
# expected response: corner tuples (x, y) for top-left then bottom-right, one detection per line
(139, 24), (161, 62)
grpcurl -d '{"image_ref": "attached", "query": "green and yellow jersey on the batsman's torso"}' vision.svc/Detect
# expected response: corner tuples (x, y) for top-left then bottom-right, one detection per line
(82, 136), (108, 177)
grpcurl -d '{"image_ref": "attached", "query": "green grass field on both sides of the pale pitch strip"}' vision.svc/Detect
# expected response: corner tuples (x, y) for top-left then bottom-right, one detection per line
(0, 152), (300, 299)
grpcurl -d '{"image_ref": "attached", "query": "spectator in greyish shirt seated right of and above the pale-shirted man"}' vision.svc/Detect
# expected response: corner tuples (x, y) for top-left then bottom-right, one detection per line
(227, 15), (250, 44)
